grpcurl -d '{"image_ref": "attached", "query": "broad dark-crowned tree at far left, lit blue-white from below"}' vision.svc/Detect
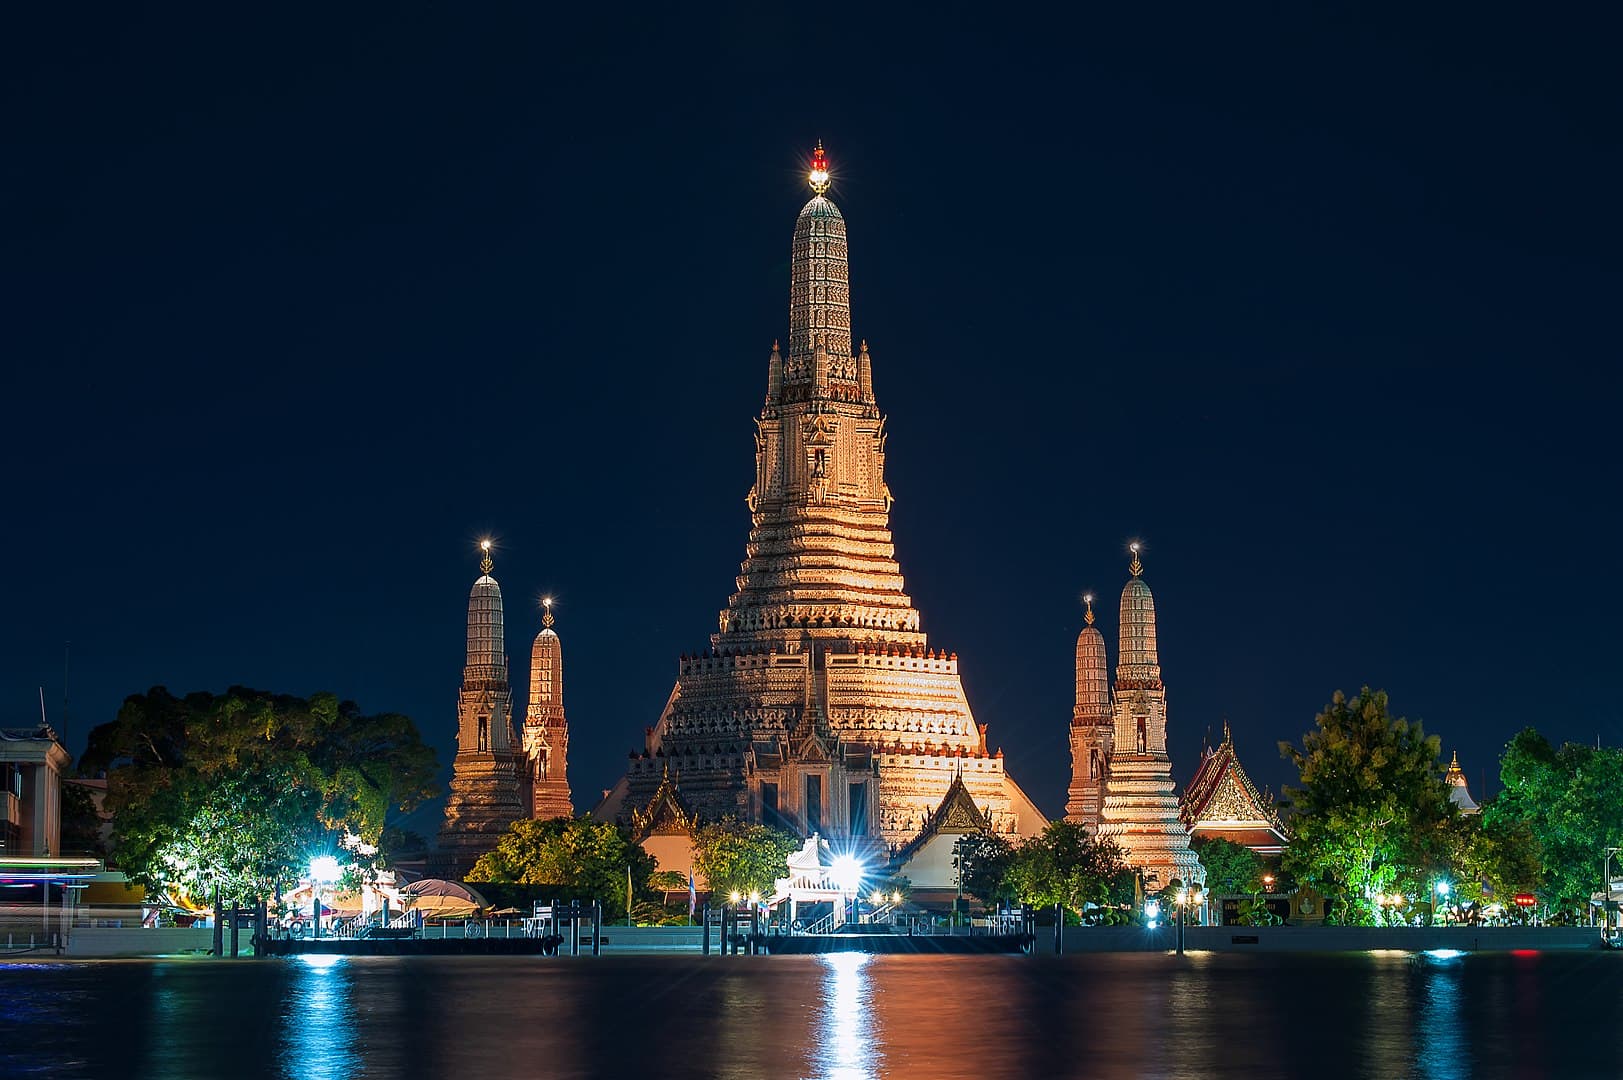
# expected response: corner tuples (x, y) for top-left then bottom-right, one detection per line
(80, 687), (437, 900)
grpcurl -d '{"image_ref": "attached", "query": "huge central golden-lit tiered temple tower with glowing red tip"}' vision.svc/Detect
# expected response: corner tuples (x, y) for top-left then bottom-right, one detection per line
(597, 148), (1044, 858)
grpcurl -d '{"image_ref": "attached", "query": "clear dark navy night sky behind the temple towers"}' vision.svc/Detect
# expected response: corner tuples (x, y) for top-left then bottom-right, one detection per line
(0, 5), (1623, 835)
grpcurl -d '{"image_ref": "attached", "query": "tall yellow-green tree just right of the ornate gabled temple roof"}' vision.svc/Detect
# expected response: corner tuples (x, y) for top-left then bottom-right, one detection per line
(1279, 687), (1457, 922)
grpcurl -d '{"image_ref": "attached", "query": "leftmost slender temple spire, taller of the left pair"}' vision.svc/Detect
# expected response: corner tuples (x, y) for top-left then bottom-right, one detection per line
(435, 541), (529, 880)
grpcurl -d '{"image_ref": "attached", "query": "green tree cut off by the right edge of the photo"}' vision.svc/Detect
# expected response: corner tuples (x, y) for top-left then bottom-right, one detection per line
(1482, 728), (1623, 908)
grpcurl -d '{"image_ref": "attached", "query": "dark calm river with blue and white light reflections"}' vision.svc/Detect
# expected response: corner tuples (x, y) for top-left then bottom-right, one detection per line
(0, 952), (1623, 1080)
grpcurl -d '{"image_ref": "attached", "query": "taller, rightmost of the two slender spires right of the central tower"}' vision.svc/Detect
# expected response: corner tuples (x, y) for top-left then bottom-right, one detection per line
(1099, 544), (1206, 890)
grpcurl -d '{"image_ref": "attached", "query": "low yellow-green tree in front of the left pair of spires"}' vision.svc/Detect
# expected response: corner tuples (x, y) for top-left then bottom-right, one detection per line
(466, 817), (657, 919)
